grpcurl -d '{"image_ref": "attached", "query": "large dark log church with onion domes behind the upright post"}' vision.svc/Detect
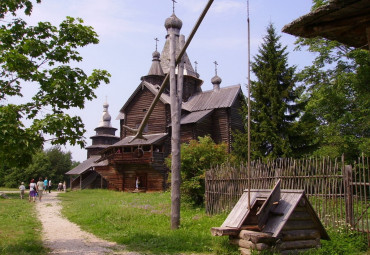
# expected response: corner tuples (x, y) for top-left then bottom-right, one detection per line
(66, 11), (244, 192)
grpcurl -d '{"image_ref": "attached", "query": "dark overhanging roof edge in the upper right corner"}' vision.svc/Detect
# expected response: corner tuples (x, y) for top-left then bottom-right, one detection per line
(283, 0), (370, 49)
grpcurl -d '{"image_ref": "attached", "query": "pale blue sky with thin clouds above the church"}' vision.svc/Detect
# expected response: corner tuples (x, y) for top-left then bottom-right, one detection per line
(13, 0), (313, 162)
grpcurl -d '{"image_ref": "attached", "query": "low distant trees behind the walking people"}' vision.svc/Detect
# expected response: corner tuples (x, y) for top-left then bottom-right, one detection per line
(0, 146), (77, 187)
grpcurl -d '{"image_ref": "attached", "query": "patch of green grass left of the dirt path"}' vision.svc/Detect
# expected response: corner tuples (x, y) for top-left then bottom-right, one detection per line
(0, 193), (47, 255)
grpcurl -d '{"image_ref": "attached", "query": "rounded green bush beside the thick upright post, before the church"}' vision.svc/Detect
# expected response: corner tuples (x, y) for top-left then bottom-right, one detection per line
(166, 136), (232, 206)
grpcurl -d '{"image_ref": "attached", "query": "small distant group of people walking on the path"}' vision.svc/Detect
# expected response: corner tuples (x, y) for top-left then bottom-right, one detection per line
(19, 177), (67, 202)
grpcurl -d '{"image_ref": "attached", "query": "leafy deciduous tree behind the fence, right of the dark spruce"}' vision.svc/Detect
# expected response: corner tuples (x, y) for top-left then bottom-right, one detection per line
(296, 0), (370, 160)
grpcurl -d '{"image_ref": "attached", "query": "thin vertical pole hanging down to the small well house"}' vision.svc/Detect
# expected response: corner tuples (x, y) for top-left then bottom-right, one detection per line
(247, 0), (251, 210)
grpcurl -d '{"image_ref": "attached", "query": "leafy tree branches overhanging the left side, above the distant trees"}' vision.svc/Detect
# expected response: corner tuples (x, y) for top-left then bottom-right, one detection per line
(0, 0), (110, 169)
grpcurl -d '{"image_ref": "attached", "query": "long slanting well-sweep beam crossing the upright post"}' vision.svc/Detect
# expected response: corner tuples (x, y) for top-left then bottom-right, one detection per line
(128, 0), (214, 142)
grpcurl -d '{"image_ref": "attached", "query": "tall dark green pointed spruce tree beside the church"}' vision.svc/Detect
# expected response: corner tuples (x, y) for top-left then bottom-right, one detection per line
(236, 24), (304, 158)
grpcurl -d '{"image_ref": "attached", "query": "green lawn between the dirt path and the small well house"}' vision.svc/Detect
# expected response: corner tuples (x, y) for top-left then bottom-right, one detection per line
(60, 190), (239, 254)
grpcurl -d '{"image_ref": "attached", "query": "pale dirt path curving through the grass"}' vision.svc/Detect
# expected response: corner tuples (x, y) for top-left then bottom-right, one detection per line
(36, 192), (138, 255)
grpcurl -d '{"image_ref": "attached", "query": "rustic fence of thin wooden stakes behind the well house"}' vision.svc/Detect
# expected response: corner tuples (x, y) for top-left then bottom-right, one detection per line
(205, 157), (370, 236)
